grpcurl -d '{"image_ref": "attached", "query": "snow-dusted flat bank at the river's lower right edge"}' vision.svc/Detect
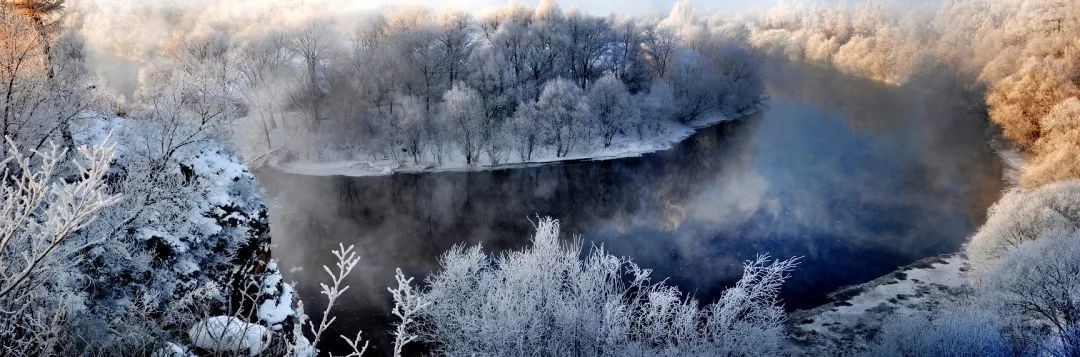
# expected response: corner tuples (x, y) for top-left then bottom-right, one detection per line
(788, 253), (969, 355)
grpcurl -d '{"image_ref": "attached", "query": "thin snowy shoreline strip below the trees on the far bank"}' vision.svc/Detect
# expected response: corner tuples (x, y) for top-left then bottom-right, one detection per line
(267, 111), (756, 177)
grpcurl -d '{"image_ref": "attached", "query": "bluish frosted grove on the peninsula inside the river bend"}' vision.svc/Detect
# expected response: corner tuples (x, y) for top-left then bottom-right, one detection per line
(219, 1), (764, 169)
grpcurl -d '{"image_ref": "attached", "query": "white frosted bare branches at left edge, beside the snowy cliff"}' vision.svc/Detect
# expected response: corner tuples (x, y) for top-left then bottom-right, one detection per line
(0, 140), (120, 355)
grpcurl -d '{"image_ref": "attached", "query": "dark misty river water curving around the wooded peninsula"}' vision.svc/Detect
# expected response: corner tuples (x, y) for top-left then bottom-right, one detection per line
(258, 60), (1002, 352)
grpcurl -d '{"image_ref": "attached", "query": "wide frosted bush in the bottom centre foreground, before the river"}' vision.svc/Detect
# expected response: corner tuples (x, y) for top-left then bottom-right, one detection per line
(392, 218), (796, 356)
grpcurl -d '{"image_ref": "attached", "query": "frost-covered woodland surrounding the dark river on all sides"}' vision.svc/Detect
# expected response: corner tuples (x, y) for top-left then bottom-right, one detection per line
(0, 0), (1080, 356)
